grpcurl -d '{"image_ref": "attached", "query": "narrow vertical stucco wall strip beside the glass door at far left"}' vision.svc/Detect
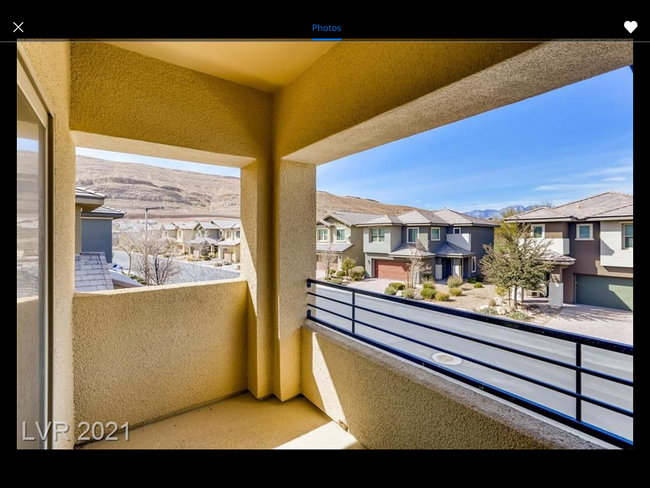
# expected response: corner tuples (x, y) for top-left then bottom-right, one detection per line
(18, 42), (75, 448)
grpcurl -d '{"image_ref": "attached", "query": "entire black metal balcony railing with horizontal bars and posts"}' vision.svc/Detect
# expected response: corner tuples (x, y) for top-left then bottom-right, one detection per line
(307, 279), (634, 448)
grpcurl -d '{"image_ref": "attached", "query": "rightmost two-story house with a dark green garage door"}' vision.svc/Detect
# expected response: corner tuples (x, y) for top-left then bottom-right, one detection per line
(506, 192), (633, 311)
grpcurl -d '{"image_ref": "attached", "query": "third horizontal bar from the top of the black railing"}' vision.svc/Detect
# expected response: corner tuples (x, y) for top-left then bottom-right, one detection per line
(310, 304), (634, 417)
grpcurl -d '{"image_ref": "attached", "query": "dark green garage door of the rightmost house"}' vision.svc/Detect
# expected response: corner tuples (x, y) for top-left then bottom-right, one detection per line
(576, 275), (633, 311)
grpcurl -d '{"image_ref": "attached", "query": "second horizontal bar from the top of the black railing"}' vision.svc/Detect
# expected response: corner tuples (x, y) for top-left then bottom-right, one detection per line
(307, 292), (634, 387)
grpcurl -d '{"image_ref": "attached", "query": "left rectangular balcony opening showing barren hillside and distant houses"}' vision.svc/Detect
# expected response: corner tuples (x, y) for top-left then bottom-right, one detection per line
(75, 147), (242, 292)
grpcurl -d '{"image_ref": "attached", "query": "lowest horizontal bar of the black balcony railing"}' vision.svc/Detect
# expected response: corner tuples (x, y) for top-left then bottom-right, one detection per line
(307, 310), (634, 448)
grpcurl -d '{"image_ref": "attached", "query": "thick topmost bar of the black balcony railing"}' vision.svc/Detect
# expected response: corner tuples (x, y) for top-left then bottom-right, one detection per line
(307, 278), (634, 356)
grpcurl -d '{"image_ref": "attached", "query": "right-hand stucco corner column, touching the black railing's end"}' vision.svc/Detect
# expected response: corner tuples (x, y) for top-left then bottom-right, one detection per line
(273, 160), (316, 400)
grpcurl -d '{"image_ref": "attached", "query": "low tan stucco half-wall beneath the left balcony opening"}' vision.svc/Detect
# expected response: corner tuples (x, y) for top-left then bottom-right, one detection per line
(74, 279), (247, 438)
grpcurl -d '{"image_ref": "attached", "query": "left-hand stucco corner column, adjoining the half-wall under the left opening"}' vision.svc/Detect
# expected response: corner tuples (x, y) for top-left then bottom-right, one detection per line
(242, 160), (275, 398)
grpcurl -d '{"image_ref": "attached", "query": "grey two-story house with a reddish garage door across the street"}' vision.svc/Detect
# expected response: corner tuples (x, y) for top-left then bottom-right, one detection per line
(359, 208), (498, 281)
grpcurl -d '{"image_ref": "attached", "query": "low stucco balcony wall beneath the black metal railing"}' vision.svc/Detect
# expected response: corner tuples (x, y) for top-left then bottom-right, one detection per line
(302, 322), (597, 449)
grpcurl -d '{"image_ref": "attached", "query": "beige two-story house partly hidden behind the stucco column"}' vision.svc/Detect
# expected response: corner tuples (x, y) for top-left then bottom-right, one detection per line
(316, 210), (379, 270)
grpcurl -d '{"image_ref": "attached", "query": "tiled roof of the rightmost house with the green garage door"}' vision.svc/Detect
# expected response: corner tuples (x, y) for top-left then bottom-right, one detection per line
(506, 191), (634, 222)
